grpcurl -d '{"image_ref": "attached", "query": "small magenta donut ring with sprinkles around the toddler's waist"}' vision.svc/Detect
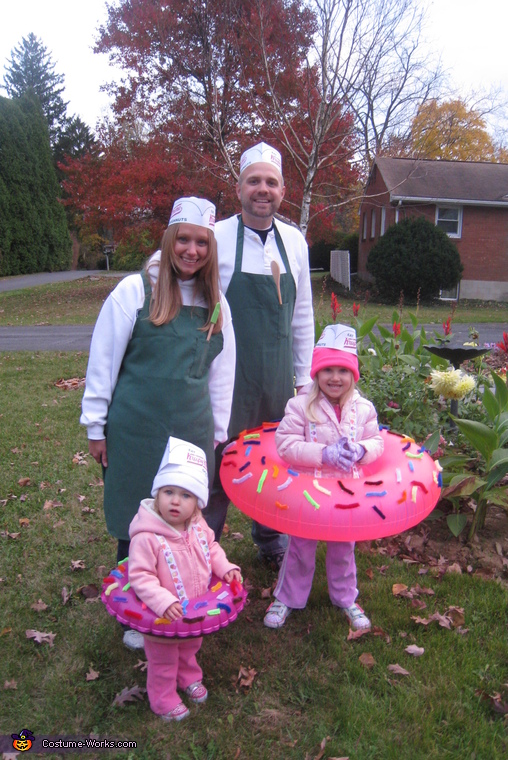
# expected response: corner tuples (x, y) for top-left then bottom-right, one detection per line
(101, 560), (247, 638)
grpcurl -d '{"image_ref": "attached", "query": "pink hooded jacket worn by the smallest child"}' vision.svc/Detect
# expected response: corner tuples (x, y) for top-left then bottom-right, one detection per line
(129, 499), (239, 617)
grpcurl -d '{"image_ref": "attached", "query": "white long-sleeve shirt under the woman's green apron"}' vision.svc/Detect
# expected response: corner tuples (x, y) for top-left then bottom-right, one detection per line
(80, 251), (236, 444)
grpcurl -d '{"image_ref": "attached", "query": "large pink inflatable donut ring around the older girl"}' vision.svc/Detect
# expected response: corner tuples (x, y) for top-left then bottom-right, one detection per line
(220, 423), (442, 541)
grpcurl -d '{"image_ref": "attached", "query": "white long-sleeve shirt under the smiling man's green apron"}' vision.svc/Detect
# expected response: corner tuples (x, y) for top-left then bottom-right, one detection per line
(215, 216), (314, 386)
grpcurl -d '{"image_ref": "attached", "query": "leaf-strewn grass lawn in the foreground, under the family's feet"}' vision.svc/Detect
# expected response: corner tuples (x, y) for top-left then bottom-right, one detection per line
(0, 354), (508, 760)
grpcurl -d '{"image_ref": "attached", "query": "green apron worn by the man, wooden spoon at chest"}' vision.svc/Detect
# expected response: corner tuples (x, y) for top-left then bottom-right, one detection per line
(226, 217), (296, 437)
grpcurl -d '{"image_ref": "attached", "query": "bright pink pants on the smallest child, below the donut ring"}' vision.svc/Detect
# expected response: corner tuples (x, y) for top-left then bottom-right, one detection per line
(144, 636), (203, 715)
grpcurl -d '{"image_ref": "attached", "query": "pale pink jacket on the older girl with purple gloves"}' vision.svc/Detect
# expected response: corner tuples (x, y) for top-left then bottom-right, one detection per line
(275, 383), (383, 477)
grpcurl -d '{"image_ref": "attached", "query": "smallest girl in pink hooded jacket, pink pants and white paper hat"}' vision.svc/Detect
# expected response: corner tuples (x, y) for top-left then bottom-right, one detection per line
(129, 438), (241, 720)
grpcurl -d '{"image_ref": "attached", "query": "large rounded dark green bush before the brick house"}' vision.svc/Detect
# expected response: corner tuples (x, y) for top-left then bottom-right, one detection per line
(367, 217), (463, 301)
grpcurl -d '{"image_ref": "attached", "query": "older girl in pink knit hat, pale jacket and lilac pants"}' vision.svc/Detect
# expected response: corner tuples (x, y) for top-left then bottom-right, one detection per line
(264, 325), (383, 629)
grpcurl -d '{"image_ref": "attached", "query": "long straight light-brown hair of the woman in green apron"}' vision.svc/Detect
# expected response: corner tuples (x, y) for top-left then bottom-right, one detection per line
(146, 224), (222, 333)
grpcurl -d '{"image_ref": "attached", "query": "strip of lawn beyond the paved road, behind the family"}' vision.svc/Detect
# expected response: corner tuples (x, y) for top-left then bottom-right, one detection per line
(0, 272), (508, 327)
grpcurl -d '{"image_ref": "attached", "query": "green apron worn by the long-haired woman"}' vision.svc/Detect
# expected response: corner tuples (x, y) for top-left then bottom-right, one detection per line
(104, 273), (224, 540)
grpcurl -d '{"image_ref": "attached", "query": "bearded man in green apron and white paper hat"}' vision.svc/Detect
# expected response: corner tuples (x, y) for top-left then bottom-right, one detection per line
(204, 143), (314, 567)
